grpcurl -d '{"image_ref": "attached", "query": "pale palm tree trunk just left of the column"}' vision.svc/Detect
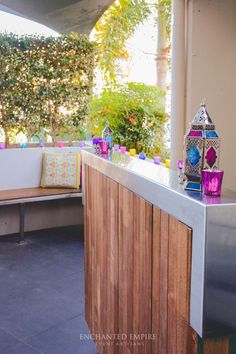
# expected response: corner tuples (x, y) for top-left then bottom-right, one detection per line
(156, 4), (169, 90)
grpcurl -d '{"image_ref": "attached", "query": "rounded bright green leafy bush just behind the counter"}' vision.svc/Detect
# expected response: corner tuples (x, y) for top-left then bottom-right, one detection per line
(88, 83), (167, 155)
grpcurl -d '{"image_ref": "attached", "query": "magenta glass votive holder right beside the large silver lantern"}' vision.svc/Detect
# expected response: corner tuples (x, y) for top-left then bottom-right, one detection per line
(202, 170), (224, 197)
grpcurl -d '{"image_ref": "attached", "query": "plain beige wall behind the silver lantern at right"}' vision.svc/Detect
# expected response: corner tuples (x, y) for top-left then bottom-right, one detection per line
(185, 0), (236, 190)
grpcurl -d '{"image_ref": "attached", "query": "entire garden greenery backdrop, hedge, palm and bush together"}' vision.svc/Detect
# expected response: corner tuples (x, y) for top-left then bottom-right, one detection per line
(0, 0), (171, 157)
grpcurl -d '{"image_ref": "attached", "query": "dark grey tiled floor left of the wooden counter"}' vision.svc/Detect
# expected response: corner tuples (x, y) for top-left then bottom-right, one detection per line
(0, 228), (96, 354)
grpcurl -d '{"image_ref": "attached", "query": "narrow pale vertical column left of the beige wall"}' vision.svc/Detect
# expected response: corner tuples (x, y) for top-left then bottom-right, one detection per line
(170, 0), (186, 169)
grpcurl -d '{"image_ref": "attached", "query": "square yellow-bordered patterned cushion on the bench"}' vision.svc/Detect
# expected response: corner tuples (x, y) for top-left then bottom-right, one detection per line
(41, 152), (80, 188)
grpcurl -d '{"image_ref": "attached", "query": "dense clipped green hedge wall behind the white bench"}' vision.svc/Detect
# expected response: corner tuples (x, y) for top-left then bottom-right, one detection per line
(0, 33), (94, 142)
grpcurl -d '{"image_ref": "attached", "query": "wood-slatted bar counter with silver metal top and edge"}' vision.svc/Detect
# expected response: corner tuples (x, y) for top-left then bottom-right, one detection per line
(82, 150), (236, 354)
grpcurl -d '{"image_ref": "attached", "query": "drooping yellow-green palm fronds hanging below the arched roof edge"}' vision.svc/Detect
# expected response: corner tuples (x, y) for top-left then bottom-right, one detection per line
(95, 0), (150, 83)
